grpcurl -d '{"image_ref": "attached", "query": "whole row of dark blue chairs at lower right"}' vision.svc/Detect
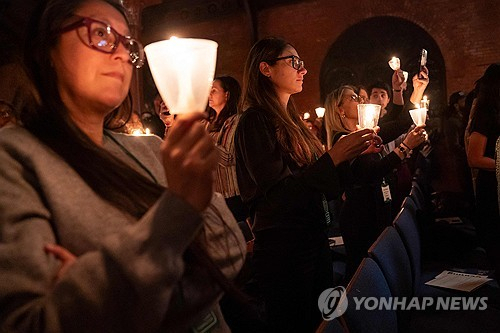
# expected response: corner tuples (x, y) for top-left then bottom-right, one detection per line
(317, 182), (500, 333)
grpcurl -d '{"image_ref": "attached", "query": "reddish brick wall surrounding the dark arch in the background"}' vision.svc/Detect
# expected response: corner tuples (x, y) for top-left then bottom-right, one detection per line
(141, 0), (500, 111)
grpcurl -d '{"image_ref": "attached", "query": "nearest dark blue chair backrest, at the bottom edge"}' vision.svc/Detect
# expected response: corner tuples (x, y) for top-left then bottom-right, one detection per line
(342, 258), (398, 333)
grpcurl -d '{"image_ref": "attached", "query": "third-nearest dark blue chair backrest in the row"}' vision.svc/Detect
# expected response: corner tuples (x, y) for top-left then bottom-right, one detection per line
(393, 208), (422, 294)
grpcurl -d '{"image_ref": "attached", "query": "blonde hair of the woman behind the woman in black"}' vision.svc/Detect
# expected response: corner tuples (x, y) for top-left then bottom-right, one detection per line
(325, 85), (356, 149)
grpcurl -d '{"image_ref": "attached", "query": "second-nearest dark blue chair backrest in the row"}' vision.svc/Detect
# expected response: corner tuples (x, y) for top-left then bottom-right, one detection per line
(368, 226), (414, 332)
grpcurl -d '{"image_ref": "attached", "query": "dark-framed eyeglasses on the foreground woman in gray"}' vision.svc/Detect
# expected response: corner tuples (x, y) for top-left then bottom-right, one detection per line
(59, 16), (144, 68)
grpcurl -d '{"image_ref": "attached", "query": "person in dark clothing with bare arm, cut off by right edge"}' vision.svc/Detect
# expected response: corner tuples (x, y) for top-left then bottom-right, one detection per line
(467, 63), (500, 280)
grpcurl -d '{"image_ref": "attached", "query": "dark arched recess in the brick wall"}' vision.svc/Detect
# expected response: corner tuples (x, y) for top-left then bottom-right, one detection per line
(320, 16), (446, 112)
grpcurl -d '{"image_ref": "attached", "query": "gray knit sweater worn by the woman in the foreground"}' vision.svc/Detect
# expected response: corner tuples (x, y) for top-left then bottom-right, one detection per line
(0, 126), (245, 332)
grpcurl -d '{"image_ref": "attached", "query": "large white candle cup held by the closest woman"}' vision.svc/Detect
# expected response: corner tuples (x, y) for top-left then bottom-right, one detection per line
(144, 38), (218, 114)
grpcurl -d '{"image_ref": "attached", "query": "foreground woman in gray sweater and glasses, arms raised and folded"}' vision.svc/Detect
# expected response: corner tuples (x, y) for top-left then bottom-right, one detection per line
(0, 0), (245, 332)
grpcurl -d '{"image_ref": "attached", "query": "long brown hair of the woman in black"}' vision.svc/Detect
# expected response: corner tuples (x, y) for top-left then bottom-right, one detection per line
(242, 37), (323, 166)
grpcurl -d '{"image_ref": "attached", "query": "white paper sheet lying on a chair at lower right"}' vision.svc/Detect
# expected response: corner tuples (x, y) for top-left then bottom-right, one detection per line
(425, 271), (492, 292)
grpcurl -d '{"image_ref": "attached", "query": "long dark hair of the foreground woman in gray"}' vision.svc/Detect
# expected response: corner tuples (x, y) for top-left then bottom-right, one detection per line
(21, 0), (242, 316)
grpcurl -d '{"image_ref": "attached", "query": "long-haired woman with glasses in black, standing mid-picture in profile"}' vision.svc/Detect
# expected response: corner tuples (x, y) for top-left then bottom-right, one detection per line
(235, 37), (375, 332)
